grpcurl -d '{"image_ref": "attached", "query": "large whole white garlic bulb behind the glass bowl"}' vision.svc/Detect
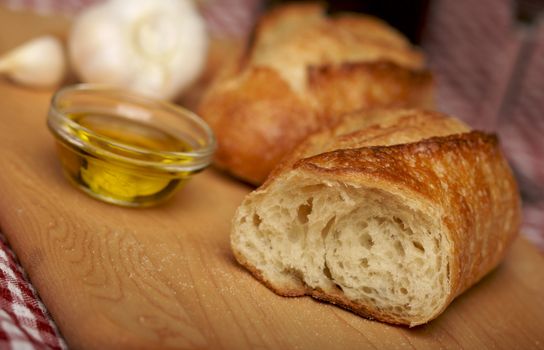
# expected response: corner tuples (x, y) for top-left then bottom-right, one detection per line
(68, 0), (208, 99)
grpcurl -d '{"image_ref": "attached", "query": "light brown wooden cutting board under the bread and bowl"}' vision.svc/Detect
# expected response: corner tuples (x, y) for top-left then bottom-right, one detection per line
(0, 6), (544, 349)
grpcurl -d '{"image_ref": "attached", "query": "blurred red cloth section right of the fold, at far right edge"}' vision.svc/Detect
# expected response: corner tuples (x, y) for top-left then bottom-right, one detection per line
(498, 19), (544, 250)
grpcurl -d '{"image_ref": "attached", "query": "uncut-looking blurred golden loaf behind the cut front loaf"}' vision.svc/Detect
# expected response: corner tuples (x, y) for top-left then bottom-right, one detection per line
(198, 4), (433, 184)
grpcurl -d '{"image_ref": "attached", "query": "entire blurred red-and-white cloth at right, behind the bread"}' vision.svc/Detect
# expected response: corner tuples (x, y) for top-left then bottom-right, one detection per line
(423, 0), (544, 251)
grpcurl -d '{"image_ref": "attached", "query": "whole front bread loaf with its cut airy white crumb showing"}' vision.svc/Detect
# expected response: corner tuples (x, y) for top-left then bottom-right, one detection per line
(231, 109), (520, 326)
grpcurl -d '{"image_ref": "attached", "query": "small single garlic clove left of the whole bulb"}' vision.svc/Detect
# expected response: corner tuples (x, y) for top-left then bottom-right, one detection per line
(0, 35), (66, 87)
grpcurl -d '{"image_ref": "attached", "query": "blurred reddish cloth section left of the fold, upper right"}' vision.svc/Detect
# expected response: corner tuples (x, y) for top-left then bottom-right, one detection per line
(423, 0), (520, 130)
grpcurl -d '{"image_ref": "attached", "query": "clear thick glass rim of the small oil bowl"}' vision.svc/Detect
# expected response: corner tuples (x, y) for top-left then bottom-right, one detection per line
(47, 84), (216, 170)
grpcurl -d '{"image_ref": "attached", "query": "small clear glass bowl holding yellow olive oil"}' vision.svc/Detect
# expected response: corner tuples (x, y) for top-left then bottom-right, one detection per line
(47, 84), (216, 207)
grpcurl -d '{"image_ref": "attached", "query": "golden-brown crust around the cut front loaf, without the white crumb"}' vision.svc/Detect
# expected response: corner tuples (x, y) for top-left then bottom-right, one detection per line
(232, 110), (521, 325)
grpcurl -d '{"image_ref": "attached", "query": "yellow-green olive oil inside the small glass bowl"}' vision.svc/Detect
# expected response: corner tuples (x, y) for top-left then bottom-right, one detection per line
(55, 113), (195, 206)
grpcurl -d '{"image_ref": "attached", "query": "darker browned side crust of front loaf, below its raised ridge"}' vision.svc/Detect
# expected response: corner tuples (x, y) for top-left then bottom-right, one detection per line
(293, 131), (520, 322)
